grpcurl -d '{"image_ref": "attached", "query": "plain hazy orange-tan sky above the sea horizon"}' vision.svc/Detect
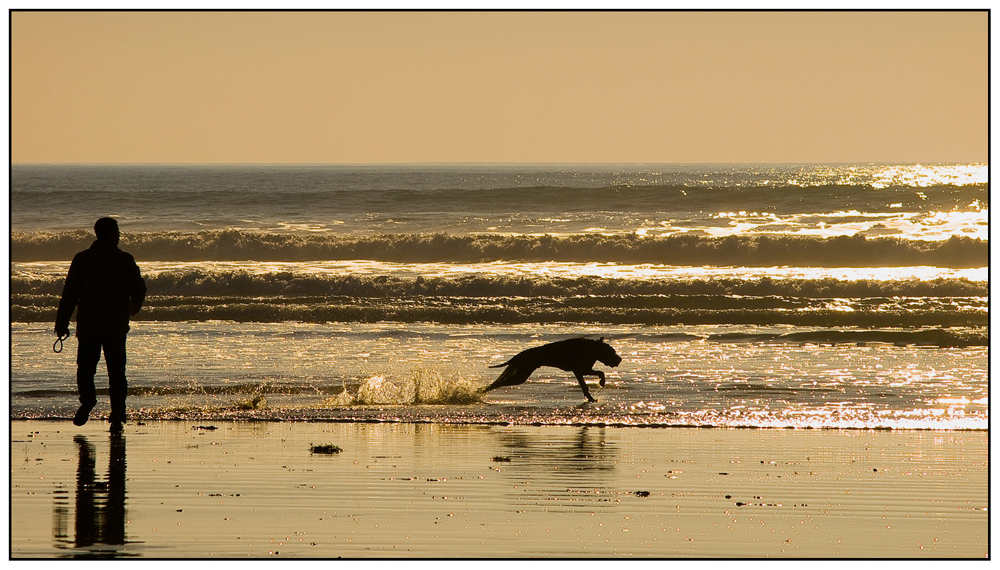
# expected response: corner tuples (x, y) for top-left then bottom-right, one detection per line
(11, 12), (989, 163)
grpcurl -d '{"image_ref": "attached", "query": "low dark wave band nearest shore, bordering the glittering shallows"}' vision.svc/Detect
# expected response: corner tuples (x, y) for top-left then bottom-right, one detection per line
(10, 295), (989, 327)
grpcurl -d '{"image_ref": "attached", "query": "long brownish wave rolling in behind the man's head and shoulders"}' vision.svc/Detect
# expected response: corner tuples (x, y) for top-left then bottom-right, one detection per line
(10, 229), (989, 268)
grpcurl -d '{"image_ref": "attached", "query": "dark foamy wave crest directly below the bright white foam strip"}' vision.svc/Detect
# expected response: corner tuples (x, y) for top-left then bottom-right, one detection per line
(10, 268), (989, 298)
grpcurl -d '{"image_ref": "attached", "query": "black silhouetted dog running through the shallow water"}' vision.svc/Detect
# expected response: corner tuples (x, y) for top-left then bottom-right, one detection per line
(484, 337), (622, 402)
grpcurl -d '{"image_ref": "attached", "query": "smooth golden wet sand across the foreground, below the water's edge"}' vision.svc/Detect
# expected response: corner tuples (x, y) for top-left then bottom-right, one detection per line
(10, 420), (989, 559)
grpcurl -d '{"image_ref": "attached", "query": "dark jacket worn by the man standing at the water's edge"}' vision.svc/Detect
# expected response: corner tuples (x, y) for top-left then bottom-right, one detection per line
(56, 240), (146, 338)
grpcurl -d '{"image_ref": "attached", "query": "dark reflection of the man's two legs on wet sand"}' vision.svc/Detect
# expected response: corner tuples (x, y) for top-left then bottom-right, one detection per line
(55, 432), (125, 556)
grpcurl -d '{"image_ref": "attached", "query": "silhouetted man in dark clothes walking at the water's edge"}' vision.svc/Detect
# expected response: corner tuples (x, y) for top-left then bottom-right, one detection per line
(56, 218), (146, 431)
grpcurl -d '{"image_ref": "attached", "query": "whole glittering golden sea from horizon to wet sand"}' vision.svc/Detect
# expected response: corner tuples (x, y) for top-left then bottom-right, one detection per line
(11, 164), (989, 429)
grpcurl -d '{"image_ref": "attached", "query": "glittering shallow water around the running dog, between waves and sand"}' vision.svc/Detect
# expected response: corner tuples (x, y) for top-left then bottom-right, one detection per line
(11, 322), (989, 429)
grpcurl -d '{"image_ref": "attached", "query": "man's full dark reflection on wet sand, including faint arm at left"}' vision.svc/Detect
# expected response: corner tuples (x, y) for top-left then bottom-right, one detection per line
(53, 433), (126, 558)
